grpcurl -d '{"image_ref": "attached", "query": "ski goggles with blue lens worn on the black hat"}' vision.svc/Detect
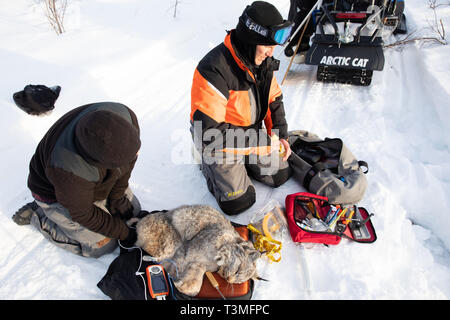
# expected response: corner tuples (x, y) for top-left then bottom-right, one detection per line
(242, 12), (294, 45)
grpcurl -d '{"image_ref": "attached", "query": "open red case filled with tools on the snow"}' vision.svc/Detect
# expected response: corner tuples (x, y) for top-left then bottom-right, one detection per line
(285, 192), (377, 245)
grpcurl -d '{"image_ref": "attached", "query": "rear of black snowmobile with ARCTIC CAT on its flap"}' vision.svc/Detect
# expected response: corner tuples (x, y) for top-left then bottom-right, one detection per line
(288, 0), (406, 86)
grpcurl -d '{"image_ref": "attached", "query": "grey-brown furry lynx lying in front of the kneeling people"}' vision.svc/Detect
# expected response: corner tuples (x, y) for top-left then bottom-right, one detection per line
(136, 205), (260, 296)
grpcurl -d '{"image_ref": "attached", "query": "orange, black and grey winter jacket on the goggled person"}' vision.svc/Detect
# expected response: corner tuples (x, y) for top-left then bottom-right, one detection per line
(190, 31), (287, 151)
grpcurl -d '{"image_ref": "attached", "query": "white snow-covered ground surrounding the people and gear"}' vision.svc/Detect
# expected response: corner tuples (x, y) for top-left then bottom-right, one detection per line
(0, 0), (450, 300)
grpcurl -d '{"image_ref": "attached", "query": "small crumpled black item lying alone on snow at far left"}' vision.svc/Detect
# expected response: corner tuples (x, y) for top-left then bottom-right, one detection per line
(13, 84), (61, 115)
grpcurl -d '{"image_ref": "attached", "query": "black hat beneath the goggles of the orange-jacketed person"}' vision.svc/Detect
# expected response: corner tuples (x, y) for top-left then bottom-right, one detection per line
(236, 1), (284, 45)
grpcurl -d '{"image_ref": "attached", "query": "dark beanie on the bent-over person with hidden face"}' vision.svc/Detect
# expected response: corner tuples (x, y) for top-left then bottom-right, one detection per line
(75, 110), (141, 168)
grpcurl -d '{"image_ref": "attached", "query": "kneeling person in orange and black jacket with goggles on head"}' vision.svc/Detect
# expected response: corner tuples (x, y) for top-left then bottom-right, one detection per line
(190, 1), (292, 215)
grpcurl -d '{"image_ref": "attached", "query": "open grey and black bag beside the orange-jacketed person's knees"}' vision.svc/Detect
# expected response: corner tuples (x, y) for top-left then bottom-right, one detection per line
(288, 130), (368, 204)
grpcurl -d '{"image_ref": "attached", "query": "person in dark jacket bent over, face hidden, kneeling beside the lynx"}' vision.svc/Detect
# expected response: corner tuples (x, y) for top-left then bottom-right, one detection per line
(13, 102), (141, 257)
